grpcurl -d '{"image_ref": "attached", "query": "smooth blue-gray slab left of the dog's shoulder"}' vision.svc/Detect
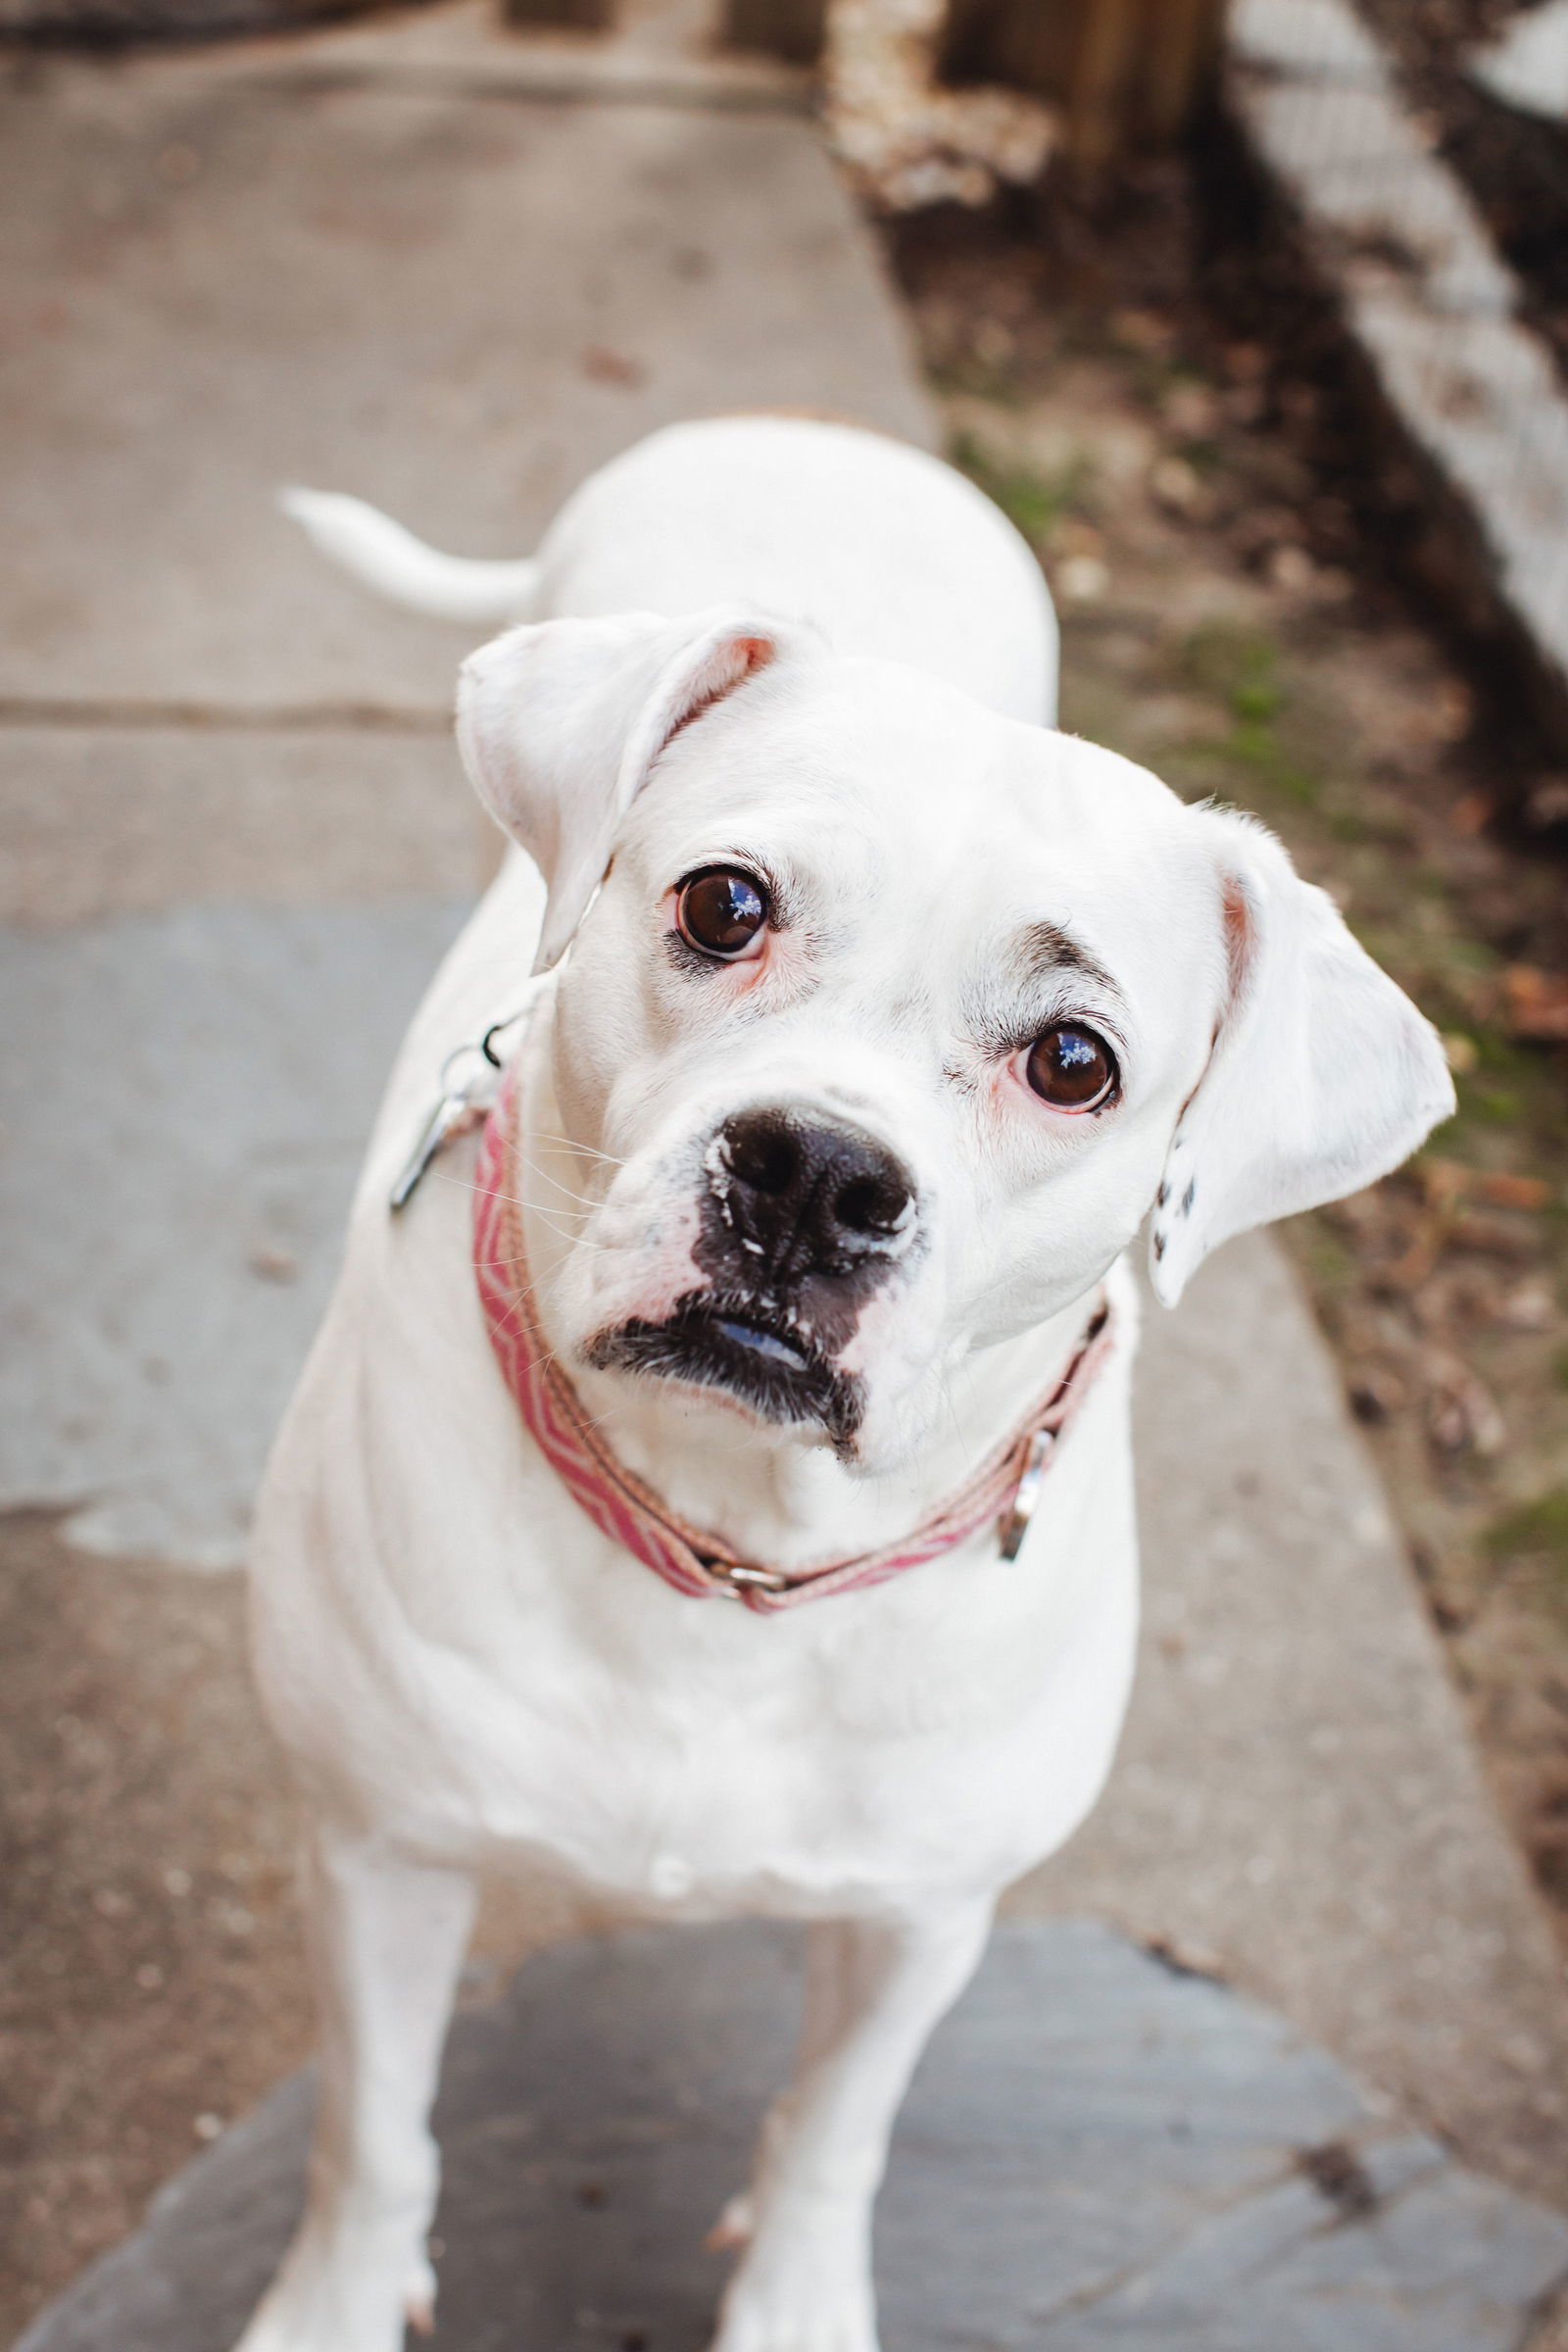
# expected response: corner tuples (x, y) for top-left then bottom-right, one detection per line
(0, 899), (466, 1566)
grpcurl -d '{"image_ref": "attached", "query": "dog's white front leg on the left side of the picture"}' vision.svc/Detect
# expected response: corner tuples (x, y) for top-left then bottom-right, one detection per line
(240, 1828), (475, 2352)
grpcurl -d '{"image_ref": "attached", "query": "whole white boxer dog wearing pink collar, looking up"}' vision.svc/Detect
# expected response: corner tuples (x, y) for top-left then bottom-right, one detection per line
(244, 418), (1452, 2352)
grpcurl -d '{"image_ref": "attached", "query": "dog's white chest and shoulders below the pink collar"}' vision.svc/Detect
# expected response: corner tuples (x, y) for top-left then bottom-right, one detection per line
(256, 1129), (1136, 1915)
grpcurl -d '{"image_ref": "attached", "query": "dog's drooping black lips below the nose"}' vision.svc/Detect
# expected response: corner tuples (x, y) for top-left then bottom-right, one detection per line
(585, 1292), (862, 1448)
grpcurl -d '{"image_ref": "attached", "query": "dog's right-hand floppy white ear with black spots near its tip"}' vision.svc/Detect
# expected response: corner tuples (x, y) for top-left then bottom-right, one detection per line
(1150, 809), (1452, 1307)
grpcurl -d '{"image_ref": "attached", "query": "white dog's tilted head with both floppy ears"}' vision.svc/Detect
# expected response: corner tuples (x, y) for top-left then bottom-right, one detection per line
(459, 612), (1452, 1470)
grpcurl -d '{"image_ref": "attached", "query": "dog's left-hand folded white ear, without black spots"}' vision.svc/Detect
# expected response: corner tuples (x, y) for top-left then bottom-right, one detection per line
(459, 610), (780, 971)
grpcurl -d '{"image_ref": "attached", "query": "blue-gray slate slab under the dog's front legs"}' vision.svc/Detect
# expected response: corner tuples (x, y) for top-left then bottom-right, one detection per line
(19, 1922), (1568, 2352)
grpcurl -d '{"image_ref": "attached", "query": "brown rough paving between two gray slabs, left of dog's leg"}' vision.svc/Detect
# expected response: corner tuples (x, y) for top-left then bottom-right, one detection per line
(0, 1515), (311, 2342)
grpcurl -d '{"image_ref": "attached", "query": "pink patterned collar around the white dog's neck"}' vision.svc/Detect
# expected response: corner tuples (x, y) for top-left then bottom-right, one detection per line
(475, 1082), (1114, 1613)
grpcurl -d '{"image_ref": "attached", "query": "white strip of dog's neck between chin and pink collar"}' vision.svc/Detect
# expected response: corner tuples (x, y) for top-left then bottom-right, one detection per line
(514, 998), (1086, 1569)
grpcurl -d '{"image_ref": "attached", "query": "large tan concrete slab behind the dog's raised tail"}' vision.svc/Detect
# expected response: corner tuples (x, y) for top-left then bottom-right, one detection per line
(0, 31), (933, 715)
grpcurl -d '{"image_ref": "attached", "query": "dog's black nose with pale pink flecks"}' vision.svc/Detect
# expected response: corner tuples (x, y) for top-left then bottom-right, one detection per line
(714, 1110), (914, 1284)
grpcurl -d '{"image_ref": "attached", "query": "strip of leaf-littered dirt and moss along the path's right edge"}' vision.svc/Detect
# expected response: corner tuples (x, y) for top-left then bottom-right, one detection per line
(894, 167), (1568, 1945)
